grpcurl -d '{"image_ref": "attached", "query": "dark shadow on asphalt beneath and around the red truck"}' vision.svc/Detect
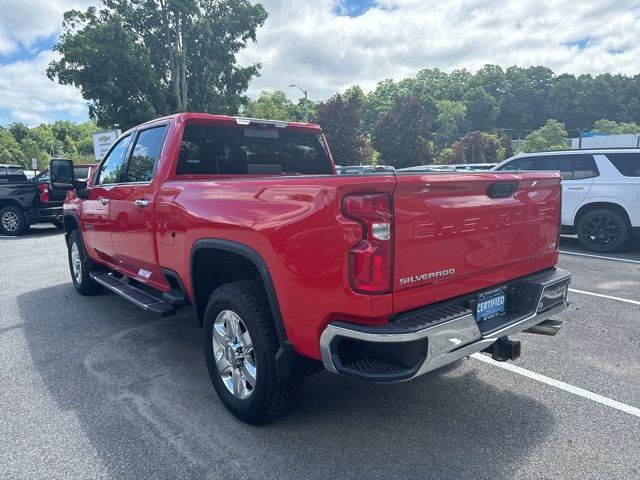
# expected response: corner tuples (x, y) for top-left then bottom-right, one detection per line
(17, 283), (555, 479)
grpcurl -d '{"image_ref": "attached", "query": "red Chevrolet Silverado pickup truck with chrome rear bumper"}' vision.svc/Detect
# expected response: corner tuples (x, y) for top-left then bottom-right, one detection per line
(50, 113), (571, 423)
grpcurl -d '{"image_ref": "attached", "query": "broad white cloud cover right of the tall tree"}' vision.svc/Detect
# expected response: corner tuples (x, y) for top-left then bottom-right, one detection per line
(239, 0), (640, 98)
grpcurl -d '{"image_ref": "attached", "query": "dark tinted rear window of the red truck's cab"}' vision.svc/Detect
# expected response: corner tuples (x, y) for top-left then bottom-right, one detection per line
(176, 125), (333, 175)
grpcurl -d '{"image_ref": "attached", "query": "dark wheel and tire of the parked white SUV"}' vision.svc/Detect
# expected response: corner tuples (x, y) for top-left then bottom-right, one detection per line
(577, 208), (631, 253)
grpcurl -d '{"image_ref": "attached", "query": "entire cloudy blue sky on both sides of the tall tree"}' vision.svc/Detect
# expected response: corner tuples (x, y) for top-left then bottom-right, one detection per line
(0, 0), (640, 125)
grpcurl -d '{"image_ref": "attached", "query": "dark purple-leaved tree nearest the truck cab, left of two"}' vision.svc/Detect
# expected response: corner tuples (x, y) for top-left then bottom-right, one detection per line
(315, 87), (373, 165)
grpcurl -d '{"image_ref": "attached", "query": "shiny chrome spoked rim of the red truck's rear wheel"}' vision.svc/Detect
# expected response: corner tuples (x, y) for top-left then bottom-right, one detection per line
(213, 310), (256, 399)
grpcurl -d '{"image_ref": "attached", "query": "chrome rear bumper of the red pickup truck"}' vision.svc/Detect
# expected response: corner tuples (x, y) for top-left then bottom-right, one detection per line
(320, 270), (571, 381)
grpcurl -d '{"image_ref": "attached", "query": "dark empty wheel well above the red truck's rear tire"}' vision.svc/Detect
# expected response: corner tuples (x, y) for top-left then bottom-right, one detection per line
(191, 248), (262, 324)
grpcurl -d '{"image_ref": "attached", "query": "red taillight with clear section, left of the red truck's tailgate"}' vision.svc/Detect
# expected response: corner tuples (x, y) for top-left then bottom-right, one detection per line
(342, 194), (392, 294)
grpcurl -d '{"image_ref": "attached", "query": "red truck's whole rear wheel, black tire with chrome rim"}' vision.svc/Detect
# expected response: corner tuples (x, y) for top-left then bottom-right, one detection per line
(203, 280), (303, 425)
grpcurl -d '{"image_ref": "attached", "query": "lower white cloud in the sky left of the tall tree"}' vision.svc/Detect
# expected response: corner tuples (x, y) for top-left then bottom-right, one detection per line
(0, 51), (88, 125)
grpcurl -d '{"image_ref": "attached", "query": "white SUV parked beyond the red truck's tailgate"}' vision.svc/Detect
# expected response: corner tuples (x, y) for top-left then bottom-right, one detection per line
(492, 148), (640, 252)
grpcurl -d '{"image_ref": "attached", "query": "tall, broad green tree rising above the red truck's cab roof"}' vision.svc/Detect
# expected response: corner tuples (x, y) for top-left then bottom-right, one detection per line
(47, 0), (267, 128)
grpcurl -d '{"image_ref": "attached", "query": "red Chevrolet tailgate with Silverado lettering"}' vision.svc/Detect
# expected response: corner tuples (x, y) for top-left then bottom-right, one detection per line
(393, 172), (561, 313)
